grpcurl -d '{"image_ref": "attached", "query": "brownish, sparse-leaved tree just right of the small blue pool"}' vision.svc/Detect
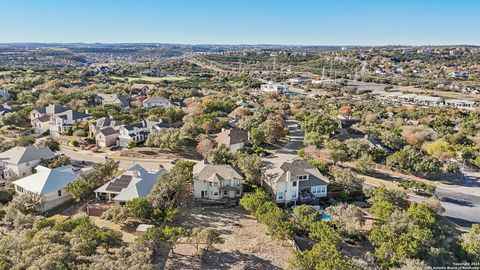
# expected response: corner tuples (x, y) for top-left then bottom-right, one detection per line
(326, 203), (365, 236)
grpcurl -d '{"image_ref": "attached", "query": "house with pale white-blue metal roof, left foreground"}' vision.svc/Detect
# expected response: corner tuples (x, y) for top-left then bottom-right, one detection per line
(13, 165), (80, 212)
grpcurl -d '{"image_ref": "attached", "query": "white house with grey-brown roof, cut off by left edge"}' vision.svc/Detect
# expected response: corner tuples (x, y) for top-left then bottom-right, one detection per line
(0, 145), (55, 178)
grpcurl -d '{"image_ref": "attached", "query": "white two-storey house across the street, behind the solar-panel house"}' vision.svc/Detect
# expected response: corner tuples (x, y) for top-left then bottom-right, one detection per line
(117, 119), (167, 147)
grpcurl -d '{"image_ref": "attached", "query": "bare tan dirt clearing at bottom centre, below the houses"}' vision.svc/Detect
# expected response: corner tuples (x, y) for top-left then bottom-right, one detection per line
(165, 207), (294, 269)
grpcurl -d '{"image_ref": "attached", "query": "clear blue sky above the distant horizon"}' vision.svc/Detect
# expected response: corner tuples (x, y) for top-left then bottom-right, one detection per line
(0, 0), (480, 45)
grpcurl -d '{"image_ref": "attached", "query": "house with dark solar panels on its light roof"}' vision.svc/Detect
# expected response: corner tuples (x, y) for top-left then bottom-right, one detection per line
(95, 164), (167, 204)
